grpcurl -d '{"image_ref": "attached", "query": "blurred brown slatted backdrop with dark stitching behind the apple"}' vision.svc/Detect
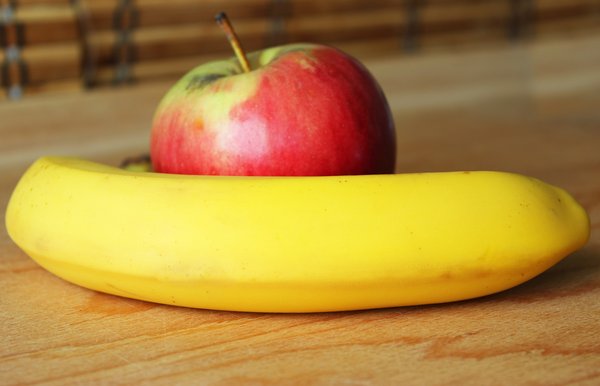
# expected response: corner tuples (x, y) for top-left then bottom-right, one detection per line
(0, 0), (600, 103)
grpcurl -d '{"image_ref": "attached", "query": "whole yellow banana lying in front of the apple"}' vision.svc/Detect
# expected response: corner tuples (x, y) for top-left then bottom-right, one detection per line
(6, 157), (590, 312)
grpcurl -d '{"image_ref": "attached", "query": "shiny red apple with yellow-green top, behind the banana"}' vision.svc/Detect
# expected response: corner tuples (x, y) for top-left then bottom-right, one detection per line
(151, 44), (396, 176)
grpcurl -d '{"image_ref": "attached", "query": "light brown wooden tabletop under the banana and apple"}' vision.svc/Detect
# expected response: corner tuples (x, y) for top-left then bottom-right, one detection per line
(0, 36), (600, 385)
